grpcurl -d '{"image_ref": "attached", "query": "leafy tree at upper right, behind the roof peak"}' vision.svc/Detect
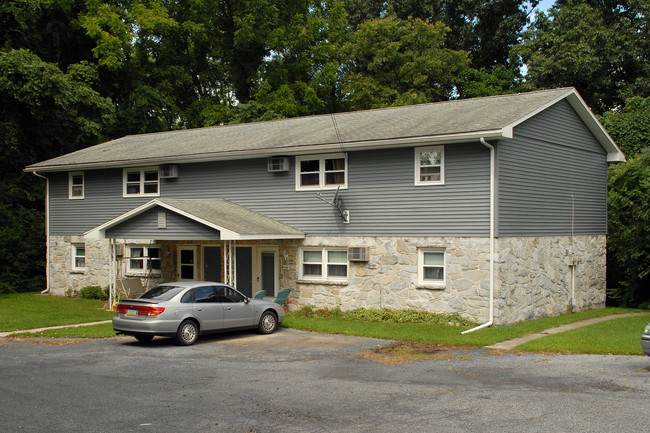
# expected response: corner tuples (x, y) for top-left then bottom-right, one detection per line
(513, 1), (650, 113)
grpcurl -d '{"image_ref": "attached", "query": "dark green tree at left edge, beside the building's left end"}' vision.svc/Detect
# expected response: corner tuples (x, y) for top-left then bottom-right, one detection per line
(0, 50), (113, 293)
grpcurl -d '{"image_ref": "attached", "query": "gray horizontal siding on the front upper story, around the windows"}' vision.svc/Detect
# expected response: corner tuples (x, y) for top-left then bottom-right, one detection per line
(50, 143), (489, 239)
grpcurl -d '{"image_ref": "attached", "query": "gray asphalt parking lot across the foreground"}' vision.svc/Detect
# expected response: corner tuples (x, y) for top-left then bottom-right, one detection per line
(0, 329), (650, 433)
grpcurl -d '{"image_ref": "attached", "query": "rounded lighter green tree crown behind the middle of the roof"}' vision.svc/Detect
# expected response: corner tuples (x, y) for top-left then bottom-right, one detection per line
(342, 17), (470, 110)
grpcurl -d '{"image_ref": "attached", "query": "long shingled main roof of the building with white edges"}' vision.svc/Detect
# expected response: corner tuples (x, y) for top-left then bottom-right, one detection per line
(26, 88), (625, 171)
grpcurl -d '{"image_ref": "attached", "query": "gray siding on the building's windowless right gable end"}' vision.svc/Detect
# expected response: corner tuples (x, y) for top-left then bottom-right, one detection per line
(497, 101), (607, 236)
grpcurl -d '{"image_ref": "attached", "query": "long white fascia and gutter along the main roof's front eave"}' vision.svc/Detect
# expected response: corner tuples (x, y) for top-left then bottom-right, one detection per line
(24, 128), (512, 172)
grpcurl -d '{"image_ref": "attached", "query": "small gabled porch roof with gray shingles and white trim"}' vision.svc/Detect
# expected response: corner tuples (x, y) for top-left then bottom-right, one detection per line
(85, 198), (305, 240)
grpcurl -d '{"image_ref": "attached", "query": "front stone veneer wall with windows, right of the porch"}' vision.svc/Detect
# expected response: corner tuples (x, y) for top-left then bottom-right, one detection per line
(289, 237), (490, 321)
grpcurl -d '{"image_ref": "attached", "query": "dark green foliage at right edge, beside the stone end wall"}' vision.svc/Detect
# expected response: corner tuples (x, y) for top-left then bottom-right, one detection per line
(607, 147), (650, 306)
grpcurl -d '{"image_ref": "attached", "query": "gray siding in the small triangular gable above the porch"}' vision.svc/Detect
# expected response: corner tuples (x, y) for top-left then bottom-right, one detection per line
(106, 207), (221, 240)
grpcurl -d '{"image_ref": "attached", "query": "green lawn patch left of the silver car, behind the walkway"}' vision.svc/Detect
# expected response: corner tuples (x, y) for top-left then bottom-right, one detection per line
(0, 293), (115, 332)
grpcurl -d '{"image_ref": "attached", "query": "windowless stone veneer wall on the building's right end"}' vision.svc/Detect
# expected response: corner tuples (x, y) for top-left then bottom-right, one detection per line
(494, 235), (606, 325)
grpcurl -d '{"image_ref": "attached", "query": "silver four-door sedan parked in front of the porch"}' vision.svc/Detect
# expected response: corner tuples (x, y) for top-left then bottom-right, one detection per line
(113, 281), (284, 346)
